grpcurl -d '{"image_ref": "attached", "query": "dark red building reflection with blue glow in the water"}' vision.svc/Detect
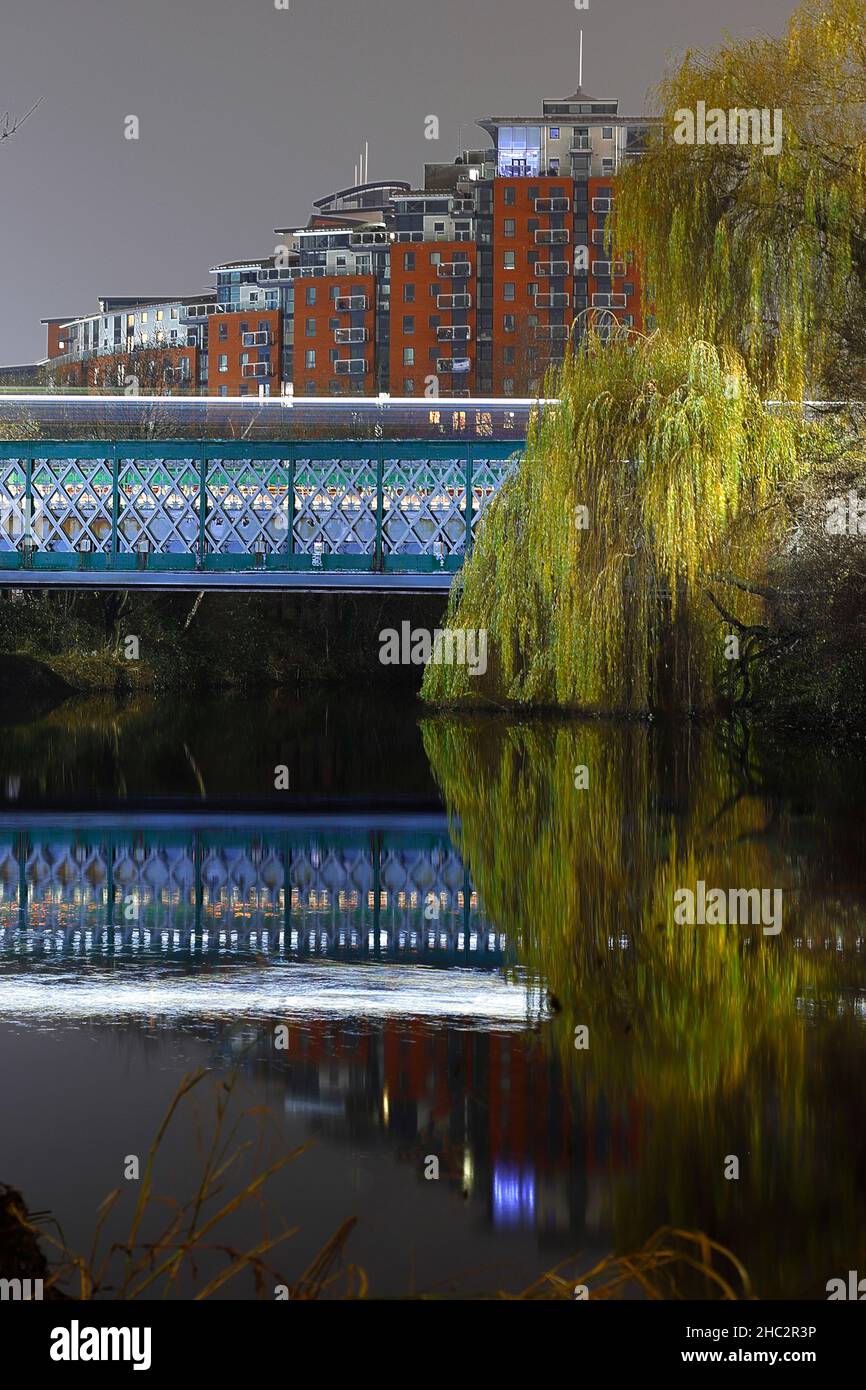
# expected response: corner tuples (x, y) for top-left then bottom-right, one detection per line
(226, 1019), (642, 1248)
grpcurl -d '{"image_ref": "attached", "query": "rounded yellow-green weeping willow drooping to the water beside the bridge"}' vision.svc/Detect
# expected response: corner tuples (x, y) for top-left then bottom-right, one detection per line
(423, 335), (812, 713)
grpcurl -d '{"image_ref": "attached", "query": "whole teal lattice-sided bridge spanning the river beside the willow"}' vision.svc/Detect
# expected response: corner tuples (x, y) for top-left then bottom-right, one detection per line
(0, 398), (528, 592)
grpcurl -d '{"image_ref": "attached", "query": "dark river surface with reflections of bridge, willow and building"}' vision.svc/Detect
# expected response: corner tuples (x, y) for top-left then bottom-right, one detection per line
(0, 695), (866, 1298)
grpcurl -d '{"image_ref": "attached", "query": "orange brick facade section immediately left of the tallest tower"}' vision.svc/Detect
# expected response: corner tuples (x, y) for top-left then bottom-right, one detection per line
(389, 242), (478, 396)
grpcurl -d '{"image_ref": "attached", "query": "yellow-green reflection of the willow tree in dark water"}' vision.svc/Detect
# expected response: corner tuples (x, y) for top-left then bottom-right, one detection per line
(424, 719), (866, 1291)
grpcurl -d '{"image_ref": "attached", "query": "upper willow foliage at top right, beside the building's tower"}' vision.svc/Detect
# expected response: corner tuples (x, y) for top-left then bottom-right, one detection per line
(610, 0), (866, 399)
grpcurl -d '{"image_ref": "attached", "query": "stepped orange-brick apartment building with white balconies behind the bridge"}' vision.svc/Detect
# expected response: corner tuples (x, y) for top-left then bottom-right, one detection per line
(35, 78), (652, 396)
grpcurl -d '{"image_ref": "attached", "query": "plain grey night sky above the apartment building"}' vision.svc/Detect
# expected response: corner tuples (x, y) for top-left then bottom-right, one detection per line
(0, 0), (795, 363)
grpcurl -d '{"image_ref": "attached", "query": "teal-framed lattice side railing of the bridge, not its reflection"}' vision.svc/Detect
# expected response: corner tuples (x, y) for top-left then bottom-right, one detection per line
(0, 439), (514, 573)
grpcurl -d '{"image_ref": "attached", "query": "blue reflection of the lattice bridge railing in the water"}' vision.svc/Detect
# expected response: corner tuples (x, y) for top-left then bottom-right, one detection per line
(0, 830), (505, 966)
